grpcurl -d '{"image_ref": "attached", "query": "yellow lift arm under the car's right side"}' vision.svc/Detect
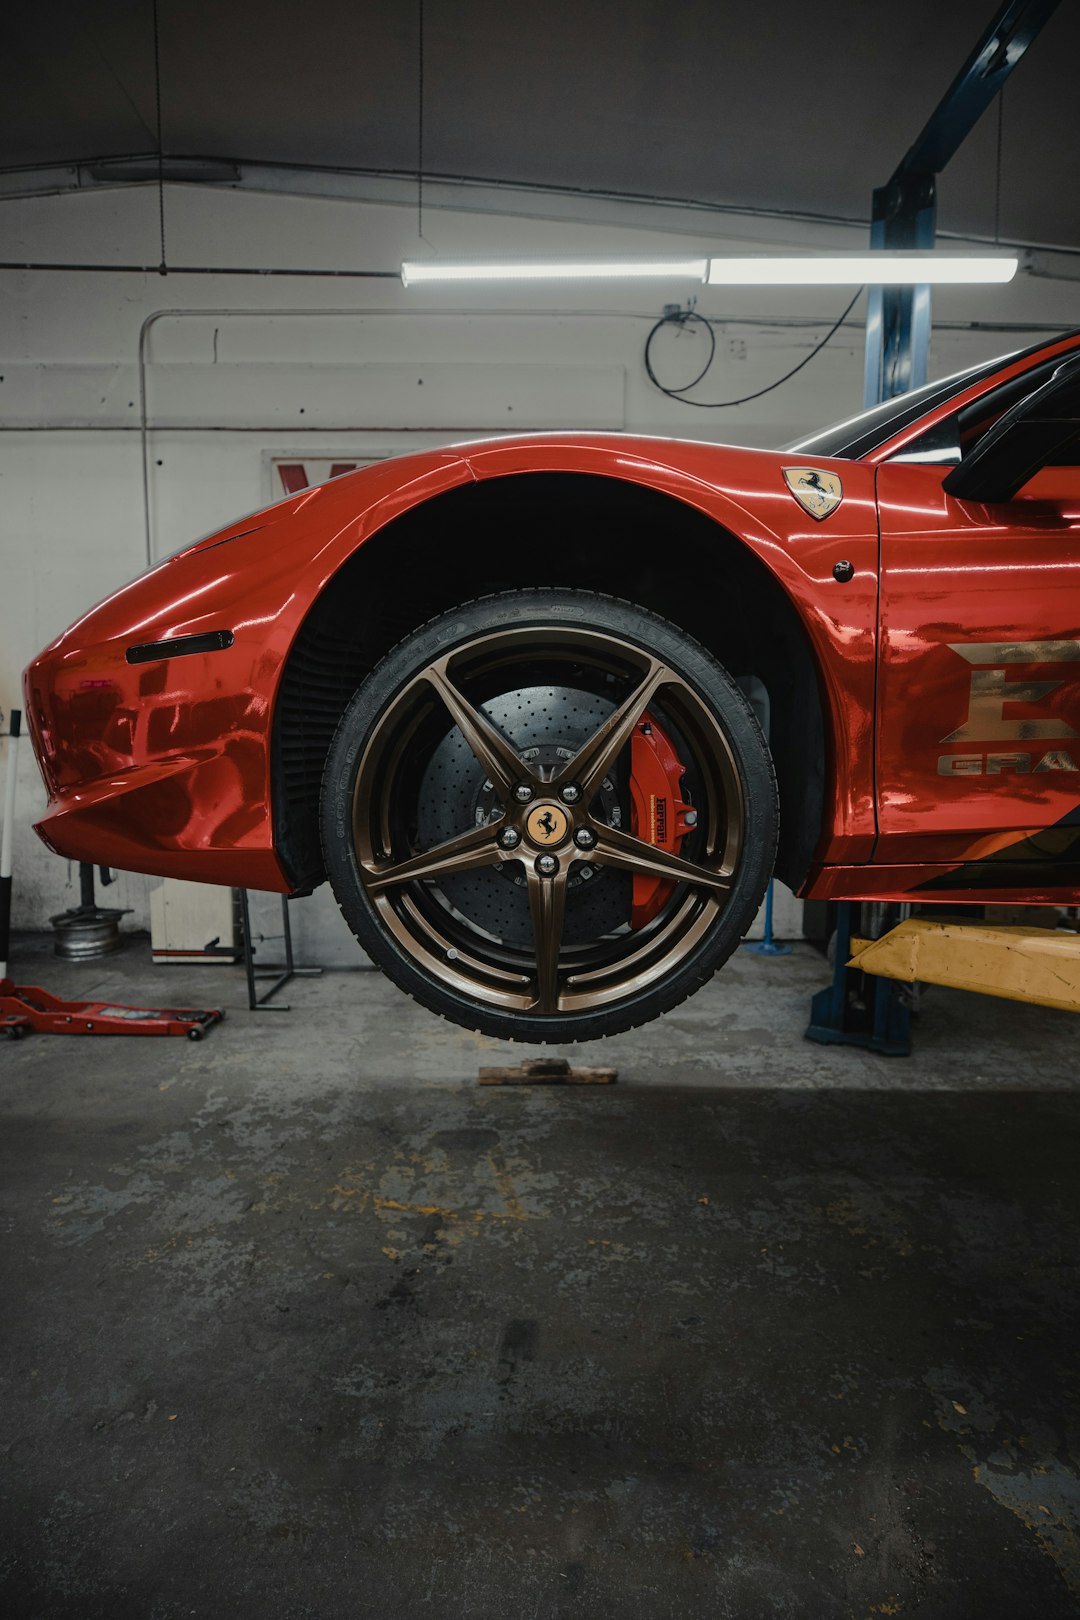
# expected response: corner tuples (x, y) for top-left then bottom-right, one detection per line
(848, 917), (1080, 1013)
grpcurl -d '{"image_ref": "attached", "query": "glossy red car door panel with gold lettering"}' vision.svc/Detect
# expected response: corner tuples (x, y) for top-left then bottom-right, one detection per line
(874, 463), (1080, 865)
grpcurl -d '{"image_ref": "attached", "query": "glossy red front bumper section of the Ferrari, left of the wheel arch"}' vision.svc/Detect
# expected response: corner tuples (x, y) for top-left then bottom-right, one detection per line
(23, 454), (468, 893)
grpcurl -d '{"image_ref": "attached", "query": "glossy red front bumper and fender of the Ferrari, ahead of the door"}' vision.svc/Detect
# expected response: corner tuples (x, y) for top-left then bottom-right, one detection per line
(24, 436), (878, 891)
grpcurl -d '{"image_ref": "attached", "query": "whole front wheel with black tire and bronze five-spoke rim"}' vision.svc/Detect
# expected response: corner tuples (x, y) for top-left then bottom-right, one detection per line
(322, 590), (777, 1042)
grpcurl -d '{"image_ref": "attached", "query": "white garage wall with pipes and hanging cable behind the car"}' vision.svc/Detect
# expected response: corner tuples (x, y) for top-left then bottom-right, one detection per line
(0, 186), (1074, 961)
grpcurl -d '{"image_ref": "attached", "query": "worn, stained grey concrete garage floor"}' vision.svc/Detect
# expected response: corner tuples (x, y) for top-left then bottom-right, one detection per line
(0, 941), (1080, 1620)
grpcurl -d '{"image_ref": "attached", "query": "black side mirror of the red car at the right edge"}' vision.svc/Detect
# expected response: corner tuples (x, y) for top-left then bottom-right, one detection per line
(942, 358), (1080, 502)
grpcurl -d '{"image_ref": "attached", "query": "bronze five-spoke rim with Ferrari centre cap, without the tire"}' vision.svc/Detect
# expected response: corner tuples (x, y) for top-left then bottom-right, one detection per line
(353, 624), (745, 1016)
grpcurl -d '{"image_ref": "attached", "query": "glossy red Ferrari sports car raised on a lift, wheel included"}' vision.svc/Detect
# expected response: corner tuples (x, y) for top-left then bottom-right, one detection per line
(26, 332), (1080, 1042)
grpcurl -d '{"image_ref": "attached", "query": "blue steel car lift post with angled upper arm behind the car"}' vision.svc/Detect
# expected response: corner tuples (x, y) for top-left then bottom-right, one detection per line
(806, 0), (1059, 1056)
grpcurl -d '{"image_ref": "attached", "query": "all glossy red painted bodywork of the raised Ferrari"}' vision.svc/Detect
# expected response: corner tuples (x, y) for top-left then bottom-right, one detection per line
(24, 328), (1080, 901)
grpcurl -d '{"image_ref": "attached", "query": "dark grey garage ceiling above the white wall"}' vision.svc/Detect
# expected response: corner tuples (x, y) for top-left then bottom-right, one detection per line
(0, 0), (1080, 246)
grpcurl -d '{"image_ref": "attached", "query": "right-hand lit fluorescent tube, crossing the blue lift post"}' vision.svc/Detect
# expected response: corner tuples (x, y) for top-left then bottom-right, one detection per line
(709, 253), (1020, 287)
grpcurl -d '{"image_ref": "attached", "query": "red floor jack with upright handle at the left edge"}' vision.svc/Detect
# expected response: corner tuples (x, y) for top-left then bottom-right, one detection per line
(0, 710), (225, 1040)
